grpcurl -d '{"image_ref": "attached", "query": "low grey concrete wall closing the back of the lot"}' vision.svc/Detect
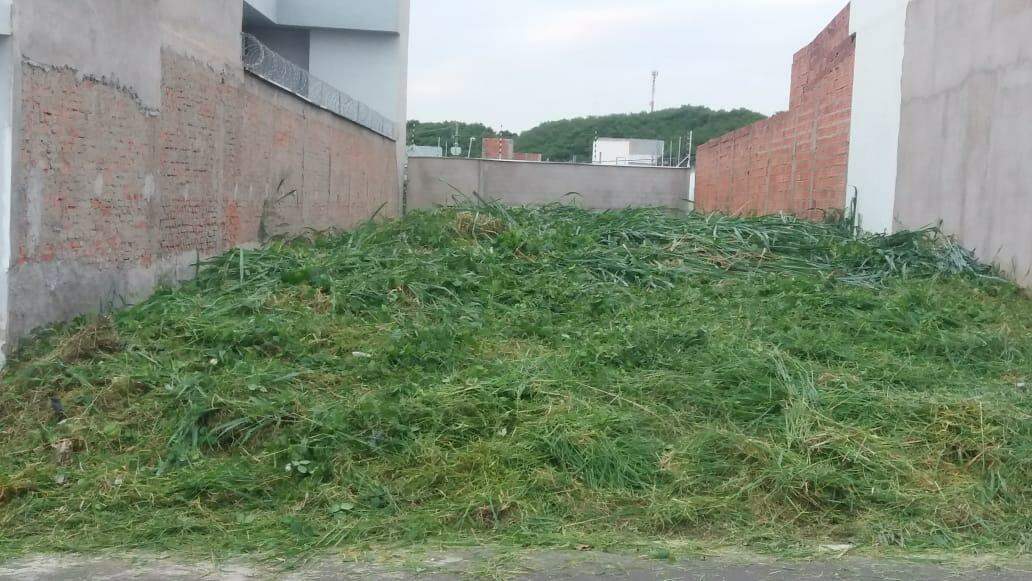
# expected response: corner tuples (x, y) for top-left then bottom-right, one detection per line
(407, 158), (690, 209)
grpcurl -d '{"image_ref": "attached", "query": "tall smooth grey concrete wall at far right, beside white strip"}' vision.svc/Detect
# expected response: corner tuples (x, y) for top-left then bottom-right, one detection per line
(895, 0), (1032, 285)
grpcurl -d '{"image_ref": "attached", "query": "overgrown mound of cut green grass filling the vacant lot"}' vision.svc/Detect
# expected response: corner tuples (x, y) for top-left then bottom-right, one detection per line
(0, 206), (1032, 553)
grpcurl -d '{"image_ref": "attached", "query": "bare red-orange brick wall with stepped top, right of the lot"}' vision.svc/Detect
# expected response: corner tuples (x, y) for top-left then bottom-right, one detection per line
(696, 6), (856, 219)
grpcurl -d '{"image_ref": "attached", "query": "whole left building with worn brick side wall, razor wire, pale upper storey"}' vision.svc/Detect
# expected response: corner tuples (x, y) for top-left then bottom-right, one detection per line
(0, 0), (409, 361)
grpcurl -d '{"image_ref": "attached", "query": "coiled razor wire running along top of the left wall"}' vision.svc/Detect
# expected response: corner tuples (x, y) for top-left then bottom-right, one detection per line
(243, 33), (397, 139)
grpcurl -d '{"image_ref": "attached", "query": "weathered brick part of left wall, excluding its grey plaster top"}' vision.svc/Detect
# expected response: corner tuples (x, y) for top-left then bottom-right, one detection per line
(9, 51), (398, 338)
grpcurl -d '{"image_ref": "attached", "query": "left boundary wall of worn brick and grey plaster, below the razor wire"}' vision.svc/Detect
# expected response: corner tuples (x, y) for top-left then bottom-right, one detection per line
(4, 0), (400, 338)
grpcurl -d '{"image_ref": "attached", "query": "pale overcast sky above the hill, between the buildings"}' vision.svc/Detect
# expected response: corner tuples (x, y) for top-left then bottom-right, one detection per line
(409, 0), (847, 131)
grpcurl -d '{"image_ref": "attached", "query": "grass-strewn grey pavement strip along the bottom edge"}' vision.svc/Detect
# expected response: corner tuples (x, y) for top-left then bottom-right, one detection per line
(0, 550), (1032, 581)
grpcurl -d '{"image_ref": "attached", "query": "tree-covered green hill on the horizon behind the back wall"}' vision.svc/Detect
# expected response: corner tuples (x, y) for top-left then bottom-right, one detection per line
(409, 105), (764, 161)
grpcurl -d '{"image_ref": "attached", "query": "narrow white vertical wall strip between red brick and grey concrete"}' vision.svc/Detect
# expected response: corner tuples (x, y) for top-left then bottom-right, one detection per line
(846, 0), (910, 232)
